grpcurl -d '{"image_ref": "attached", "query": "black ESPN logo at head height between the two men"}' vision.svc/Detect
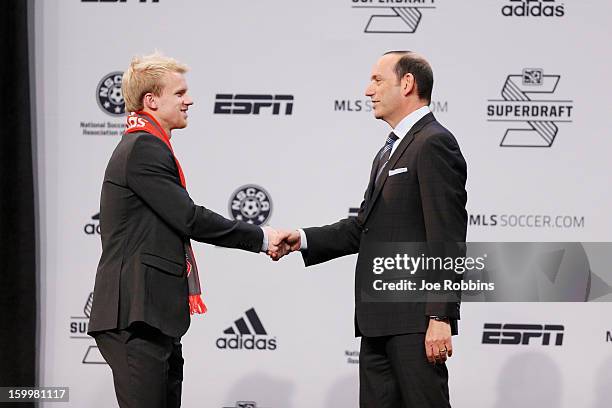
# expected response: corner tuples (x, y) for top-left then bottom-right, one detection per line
(214, 94), (293, 115)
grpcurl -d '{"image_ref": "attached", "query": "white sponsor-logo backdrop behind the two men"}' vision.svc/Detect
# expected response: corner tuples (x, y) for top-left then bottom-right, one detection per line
(33, 0), (612, 408)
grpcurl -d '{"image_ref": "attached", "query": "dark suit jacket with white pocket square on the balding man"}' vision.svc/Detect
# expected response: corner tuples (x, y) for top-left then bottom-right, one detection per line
(302, 113), (467, 337)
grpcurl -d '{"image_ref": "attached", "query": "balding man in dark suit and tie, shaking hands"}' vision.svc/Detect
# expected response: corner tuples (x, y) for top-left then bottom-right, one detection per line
(280, 51), (467, 408)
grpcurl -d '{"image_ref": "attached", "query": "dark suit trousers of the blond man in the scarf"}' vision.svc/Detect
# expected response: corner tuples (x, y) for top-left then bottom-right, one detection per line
(94, 323), (183, 408)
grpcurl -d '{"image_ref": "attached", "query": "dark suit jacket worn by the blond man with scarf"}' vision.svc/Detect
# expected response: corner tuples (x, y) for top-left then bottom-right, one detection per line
(89, 132), (263, 337)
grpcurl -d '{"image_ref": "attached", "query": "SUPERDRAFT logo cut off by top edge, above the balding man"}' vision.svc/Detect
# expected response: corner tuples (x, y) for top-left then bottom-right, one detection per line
(351, 0), (436, 34)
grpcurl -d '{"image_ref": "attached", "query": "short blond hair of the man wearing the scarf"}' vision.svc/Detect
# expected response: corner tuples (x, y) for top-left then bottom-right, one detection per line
(121, 51), (189, 112)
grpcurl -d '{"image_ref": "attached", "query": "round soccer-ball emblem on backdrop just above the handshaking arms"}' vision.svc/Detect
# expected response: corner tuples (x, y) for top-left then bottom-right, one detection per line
(229, 184), (272, 225)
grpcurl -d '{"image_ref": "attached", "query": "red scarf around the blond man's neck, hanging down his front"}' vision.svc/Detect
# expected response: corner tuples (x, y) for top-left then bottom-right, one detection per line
(125, 111), (206, 314)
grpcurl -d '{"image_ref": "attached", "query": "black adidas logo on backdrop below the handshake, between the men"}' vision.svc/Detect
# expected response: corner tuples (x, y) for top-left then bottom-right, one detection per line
(216, 308), (276, 350)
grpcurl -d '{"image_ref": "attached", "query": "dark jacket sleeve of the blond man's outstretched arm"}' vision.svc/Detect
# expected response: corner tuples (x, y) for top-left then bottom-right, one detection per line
(126, 135), (263, 252)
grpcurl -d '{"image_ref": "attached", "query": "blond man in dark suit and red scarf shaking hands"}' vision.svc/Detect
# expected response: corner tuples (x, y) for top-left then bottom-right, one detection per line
(89, 53), (280, 408)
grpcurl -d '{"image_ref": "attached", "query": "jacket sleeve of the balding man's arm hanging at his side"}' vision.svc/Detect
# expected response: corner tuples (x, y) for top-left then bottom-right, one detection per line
(417, 133), (467, 319)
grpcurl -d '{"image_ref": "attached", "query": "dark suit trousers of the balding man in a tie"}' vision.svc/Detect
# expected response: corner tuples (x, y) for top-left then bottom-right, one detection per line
(359, 333), (450, 408)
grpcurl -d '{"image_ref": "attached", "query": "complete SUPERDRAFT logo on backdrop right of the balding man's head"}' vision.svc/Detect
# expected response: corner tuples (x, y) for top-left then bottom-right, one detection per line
(487, 68), (574, 147)
